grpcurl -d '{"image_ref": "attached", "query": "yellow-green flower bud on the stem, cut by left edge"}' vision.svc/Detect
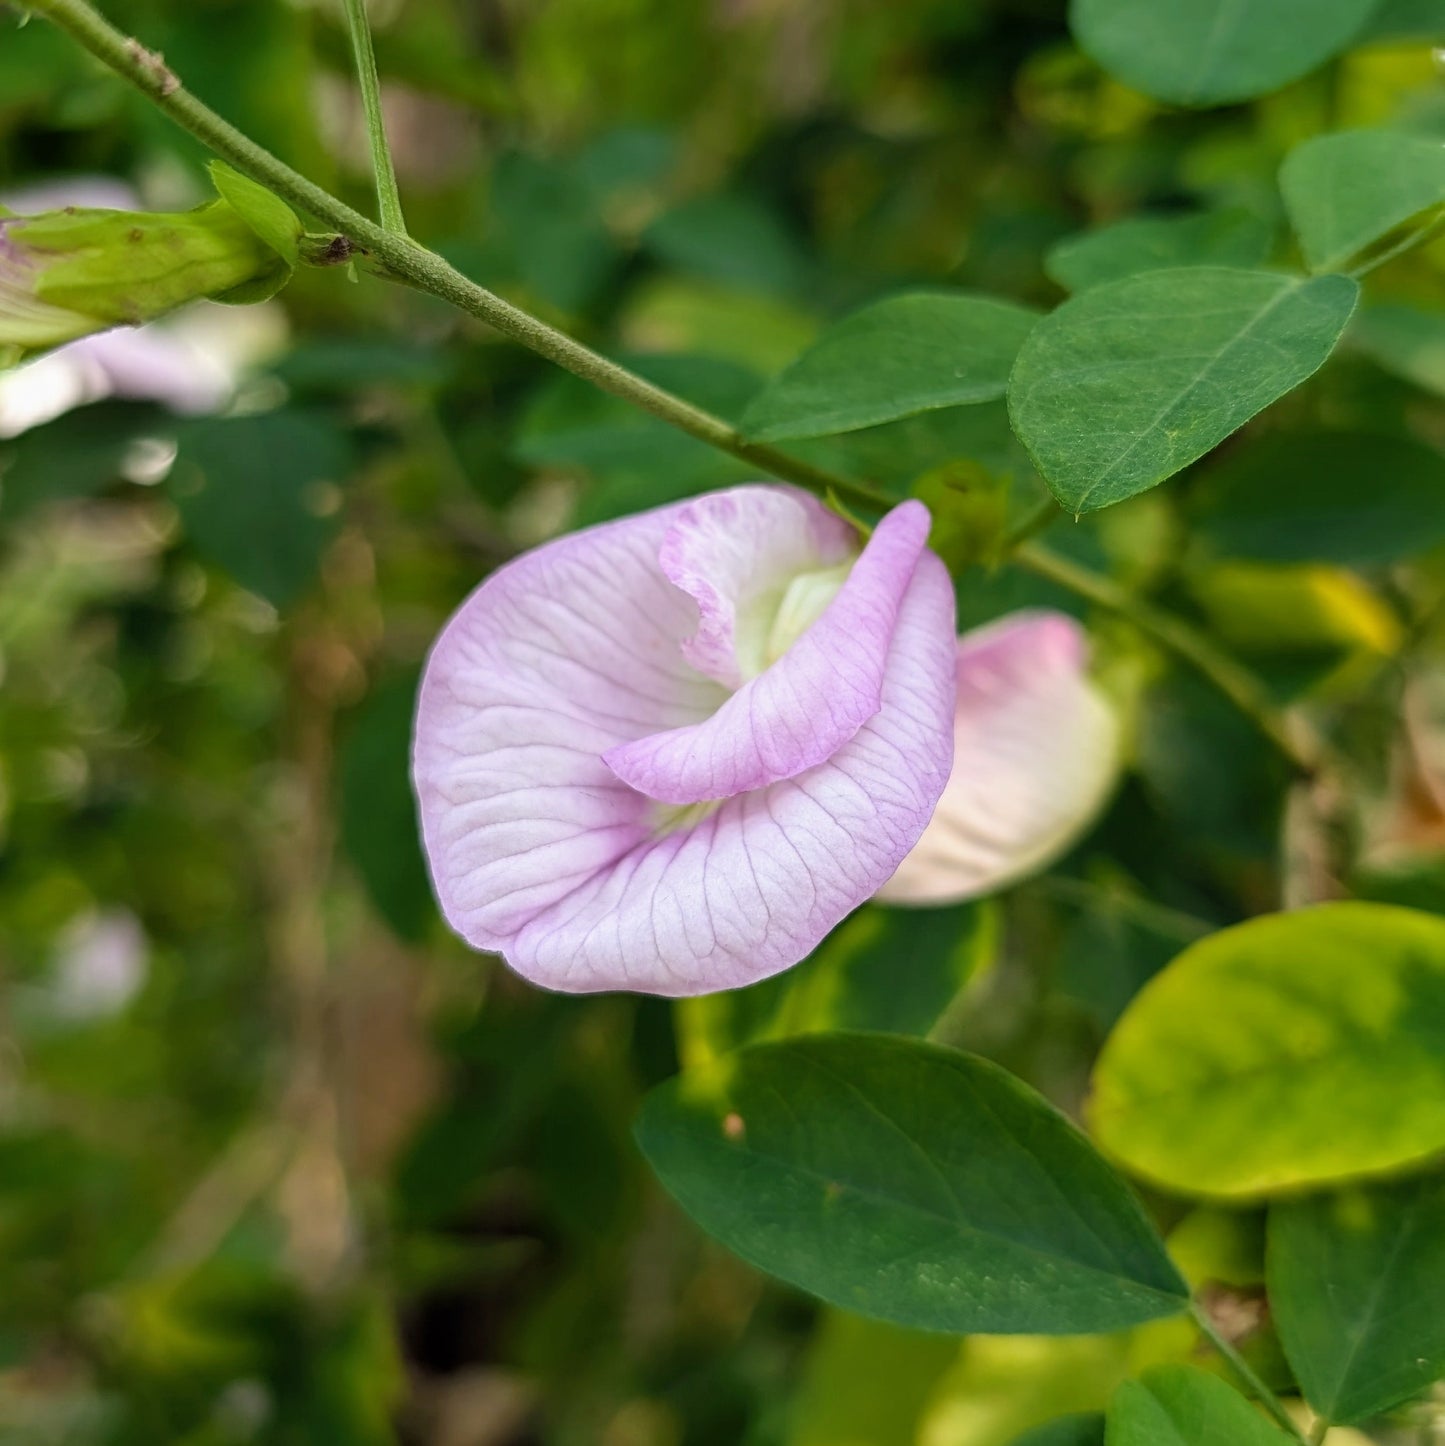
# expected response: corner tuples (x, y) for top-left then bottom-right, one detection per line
(0, 172), (299, 359)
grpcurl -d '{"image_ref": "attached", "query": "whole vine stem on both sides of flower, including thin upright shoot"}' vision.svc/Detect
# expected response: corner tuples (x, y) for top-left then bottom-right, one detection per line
(25, 0), (1328, 777)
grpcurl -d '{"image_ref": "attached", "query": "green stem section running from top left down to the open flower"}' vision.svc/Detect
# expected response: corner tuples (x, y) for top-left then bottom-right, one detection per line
(27, 0), (895, 523)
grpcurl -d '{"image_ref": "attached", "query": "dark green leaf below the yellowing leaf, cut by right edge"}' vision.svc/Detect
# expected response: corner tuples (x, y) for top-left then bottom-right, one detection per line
(1267, 1176), (1445, 1426)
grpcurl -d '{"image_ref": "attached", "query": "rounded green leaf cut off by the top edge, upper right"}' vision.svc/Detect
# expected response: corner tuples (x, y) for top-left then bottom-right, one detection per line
(1069, 0), (1376, 106)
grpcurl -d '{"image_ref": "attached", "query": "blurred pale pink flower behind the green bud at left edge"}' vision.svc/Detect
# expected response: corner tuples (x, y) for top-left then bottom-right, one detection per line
(0, 176), (285, 437)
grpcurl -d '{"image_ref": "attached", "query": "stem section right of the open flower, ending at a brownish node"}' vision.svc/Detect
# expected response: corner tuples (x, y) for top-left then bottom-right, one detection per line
(1014, 542), (1329, 777)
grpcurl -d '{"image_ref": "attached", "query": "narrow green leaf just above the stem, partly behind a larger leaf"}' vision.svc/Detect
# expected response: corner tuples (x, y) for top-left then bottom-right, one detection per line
(742, 292), (1039, 441)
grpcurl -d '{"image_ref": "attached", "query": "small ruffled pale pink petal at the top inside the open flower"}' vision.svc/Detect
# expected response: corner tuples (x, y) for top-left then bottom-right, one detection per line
(658, 486), (858, 688)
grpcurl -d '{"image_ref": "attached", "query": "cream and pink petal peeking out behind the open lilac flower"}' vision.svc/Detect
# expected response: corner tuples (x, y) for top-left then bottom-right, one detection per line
(878, 613), (1120, 904)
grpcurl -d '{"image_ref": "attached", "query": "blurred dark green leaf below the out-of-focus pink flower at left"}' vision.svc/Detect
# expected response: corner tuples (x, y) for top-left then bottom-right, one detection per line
(169, 411), (351, 607)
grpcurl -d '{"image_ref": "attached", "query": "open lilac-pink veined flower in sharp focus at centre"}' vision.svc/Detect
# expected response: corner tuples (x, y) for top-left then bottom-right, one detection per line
(415, 486), (955, 995)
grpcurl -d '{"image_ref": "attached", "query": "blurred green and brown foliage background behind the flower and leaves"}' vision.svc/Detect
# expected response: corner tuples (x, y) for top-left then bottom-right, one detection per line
(0, 0), (1445, 1446)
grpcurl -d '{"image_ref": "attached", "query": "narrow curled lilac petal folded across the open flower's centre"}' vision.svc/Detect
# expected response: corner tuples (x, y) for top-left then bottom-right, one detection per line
(606, 502), (929, 804)
